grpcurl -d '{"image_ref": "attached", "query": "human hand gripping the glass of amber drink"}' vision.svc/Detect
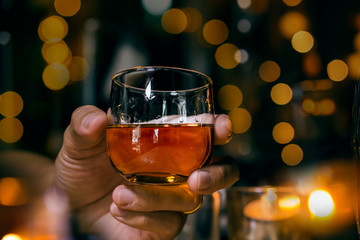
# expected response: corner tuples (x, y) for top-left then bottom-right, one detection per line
(55, 106), (239, 240)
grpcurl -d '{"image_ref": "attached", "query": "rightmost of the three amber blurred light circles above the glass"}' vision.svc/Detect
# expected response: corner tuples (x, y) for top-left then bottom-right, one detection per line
(203, 19), (229, 45)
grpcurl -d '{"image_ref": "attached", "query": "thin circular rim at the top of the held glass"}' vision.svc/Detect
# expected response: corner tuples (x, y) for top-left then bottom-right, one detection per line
(111, 66), (213, 93)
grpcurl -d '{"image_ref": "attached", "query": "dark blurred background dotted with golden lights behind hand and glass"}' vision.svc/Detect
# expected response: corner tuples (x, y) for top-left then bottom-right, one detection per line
(0, 0), (360, 239)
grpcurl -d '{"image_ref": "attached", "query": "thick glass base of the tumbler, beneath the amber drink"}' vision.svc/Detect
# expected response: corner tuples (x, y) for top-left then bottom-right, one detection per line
(124, 173), (188, 185)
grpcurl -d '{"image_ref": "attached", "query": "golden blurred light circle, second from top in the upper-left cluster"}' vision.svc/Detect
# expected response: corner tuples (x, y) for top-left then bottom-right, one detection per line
(38, 15), (68, 42)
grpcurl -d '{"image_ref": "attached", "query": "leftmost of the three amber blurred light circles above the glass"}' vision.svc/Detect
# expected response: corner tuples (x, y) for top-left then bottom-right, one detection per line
(161, 8), (187, 34)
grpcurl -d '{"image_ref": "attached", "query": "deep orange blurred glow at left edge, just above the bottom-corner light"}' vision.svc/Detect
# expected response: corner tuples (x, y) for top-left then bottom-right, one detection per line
(0, 177), (28, 206)
